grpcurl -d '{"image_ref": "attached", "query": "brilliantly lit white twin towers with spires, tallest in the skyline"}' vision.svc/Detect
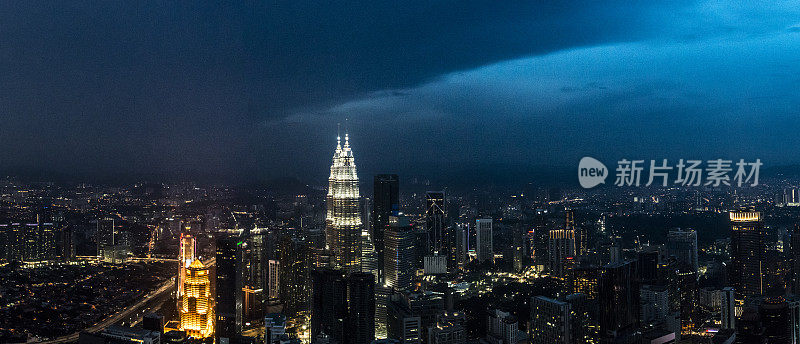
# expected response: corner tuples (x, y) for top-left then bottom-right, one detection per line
(325, 134), (368, 272)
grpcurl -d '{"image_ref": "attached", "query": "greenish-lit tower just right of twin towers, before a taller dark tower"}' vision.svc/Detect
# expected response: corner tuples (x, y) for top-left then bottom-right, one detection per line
(384, 216), (415, 290)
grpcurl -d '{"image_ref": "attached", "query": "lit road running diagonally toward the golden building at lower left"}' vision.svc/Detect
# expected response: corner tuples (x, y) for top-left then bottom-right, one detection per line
(39, 258), (216, 344)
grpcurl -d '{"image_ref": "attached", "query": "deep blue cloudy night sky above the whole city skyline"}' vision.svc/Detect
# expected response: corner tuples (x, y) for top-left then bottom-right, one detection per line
(0, 0), (800, 182)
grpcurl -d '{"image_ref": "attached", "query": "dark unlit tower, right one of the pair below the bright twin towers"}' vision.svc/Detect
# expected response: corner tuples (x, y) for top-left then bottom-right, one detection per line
(347, 272), (375, 344)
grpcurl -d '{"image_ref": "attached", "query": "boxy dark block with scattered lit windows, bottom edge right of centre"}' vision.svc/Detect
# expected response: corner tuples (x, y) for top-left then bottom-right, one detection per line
(528, 296), (572, 344)
